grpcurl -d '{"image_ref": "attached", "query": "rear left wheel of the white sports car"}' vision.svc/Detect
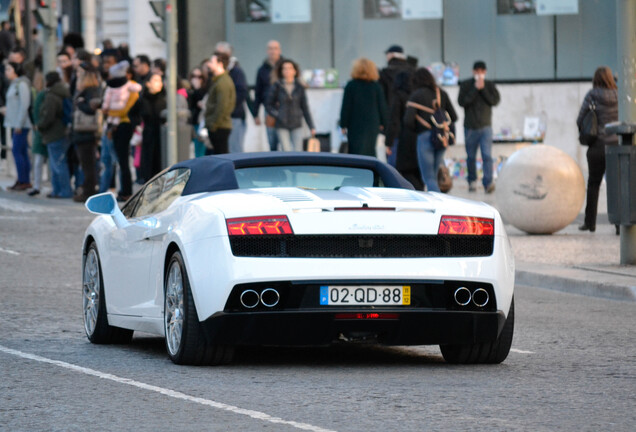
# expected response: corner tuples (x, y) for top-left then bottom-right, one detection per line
(163, 251), (234, 365)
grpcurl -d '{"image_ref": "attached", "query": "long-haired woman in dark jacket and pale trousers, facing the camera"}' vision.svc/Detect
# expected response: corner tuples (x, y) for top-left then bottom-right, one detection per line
(265, 59), (316, 151)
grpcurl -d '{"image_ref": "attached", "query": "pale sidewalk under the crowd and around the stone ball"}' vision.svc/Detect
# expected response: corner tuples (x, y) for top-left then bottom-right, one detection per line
(0, 157), (636, 301)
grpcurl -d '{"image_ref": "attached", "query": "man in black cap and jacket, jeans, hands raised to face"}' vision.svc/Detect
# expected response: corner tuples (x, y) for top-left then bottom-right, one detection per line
(458, 61), (499, 193)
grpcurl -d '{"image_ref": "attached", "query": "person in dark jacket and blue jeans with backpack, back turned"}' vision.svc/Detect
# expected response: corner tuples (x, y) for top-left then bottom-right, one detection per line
(37, 72), (73, 198)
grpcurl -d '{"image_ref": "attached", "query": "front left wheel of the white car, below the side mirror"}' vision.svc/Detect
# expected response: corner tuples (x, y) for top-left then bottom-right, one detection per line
(82, 243), (133, 344)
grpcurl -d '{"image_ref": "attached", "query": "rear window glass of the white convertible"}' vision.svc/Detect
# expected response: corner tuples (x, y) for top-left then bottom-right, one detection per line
(235, 165), (383, 189)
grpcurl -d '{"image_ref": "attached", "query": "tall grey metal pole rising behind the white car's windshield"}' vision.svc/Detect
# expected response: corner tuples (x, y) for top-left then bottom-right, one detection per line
(165, 0), (178, 166)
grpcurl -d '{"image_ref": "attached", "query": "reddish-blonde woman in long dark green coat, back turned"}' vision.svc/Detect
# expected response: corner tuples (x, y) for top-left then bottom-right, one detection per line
(340, 58), (391, 157)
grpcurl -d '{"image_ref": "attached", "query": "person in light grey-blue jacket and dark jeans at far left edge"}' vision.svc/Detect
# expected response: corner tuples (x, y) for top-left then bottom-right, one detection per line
(2, 62), (33, 191)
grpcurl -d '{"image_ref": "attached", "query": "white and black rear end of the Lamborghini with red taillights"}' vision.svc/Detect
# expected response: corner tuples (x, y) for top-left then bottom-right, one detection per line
(181, 187), (514, 354)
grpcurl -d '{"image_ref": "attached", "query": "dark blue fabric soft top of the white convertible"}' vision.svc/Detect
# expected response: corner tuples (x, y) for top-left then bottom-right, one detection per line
(170, 152), (414, 195)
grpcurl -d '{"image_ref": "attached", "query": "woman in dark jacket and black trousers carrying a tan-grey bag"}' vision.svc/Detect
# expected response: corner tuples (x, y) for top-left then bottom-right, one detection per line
(71, 63), (101, 202)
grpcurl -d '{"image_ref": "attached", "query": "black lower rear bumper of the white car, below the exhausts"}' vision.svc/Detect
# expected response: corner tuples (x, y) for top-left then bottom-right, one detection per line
(202, 309), (506, 346)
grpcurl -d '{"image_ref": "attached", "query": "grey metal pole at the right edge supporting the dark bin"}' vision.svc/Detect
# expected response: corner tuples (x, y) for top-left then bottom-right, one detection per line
(616, 0), (636, 265)
